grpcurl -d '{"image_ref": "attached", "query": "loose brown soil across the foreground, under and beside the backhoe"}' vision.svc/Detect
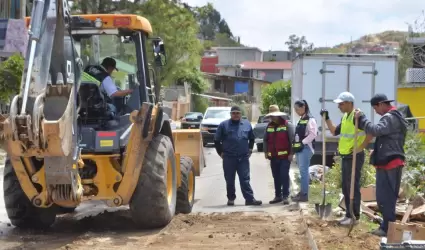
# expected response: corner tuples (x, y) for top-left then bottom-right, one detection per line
(0, 212), (311, 250)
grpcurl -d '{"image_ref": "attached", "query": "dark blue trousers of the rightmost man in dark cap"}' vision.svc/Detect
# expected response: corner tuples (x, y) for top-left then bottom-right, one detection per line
(376, 167), (402, 232)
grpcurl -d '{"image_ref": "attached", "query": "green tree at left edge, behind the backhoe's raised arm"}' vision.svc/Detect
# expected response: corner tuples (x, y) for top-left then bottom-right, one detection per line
(0, 54), (24, 102)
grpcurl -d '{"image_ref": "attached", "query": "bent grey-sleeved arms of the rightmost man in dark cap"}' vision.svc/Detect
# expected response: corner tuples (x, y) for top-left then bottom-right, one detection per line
(359, 114), (400, 137)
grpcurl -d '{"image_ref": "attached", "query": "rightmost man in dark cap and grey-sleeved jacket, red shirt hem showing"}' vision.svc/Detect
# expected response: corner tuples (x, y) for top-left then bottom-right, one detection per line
(356, 94), (408, 237)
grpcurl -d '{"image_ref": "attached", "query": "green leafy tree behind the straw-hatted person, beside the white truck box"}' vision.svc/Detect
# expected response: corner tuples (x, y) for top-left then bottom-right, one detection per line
(261, 80), (291, 113)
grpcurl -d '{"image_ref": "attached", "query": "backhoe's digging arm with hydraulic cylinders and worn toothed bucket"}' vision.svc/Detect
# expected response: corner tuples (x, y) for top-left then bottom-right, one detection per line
(4, 0), (82, 207)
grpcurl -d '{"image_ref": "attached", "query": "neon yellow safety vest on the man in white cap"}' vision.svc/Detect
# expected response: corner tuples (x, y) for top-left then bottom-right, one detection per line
(338, 111), (366, 155)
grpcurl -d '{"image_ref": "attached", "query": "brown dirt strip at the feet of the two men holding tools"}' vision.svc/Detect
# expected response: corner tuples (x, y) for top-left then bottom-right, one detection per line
(306, 216), (380, 249)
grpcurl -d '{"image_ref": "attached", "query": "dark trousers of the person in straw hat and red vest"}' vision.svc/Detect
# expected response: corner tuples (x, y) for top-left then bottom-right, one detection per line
(270, 158), (291, 198)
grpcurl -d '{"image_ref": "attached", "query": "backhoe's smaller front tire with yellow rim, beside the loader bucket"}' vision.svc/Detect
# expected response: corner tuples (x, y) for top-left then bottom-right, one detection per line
(176, 156), (195, 214)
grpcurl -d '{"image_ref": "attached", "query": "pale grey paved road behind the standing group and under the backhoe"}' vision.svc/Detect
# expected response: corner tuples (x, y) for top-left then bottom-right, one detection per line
(0, 147), (300, 239)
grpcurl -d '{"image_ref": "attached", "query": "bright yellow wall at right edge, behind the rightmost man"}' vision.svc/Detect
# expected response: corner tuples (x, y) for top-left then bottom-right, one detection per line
(397, 86), (425, 132)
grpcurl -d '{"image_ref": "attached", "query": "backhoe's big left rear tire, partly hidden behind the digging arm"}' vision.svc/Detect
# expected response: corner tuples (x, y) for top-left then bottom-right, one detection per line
(3, 158), (56, 229)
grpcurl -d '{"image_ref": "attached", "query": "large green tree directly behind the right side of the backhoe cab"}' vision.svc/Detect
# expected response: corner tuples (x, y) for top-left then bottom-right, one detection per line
(135, 0), (205, 92)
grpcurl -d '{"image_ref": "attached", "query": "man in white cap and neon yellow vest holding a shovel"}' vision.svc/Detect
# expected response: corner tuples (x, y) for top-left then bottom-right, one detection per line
(320, 92), (373, 226)
